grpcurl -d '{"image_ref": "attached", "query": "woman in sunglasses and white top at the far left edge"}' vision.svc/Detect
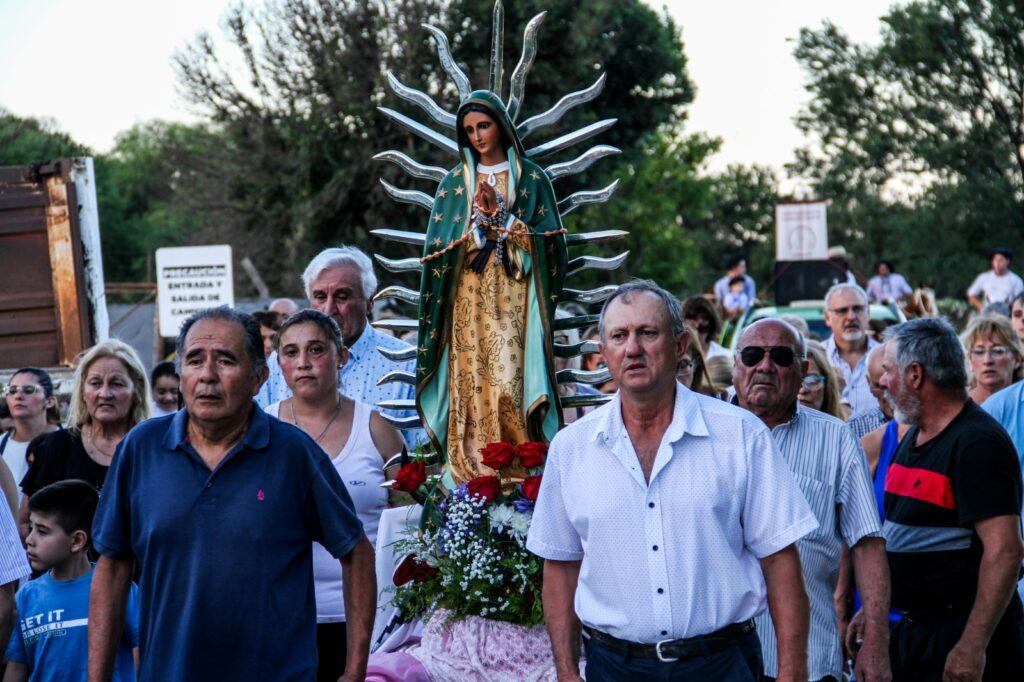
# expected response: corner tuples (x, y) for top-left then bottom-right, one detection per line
(0, 367), (60, 518)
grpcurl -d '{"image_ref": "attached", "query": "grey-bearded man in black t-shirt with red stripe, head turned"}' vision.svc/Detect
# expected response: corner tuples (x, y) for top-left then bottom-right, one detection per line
(880, 317), (1024, 681)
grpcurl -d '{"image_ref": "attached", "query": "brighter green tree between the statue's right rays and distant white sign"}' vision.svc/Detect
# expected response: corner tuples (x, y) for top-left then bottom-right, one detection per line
(566, 126), (780, 296)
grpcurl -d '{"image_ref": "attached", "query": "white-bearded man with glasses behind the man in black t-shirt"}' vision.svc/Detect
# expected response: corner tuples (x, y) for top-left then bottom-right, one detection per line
(824, 283), (879, 413)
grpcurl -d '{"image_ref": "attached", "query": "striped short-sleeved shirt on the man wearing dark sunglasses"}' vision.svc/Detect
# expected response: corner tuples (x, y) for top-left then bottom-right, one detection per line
(756, 404), (882, 680)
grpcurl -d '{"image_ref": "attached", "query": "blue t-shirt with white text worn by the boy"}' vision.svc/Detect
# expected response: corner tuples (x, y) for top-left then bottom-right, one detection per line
(6, 570), (138, 682)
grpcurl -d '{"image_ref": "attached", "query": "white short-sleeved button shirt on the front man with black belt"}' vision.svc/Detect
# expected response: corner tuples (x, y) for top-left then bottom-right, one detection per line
(526, 384), (817, 643)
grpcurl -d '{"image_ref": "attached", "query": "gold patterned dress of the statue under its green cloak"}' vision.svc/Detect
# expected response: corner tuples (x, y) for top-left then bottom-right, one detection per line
(449, 166), (530, 480)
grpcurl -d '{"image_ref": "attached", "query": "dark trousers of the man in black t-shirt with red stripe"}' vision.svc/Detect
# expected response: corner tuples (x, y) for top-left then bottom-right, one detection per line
(889, 592), (1024, 682)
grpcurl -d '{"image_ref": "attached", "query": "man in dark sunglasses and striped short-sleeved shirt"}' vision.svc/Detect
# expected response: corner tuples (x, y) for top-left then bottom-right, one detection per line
(732, 319), (891, 682)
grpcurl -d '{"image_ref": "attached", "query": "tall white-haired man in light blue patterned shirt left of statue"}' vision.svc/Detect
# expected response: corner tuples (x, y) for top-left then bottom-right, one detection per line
(256, 246), (422, 446)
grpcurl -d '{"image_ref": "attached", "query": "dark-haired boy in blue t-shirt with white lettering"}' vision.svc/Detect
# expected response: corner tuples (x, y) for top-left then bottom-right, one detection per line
(3, 480), (139, 682)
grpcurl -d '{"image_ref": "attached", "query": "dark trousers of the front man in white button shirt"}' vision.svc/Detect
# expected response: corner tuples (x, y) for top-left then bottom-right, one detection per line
(584, 630), (763, 682)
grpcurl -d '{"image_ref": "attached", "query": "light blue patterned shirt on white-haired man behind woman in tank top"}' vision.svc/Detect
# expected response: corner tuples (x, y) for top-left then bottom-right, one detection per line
(256, 323), (427, 447)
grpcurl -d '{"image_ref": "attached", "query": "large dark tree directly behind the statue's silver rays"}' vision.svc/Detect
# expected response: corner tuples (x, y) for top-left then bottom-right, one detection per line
(175, 0), (692, 293)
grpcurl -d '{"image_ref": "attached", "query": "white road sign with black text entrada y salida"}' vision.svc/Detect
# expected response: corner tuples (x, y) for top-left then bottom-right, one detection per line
(157, 245), (234, 337)
